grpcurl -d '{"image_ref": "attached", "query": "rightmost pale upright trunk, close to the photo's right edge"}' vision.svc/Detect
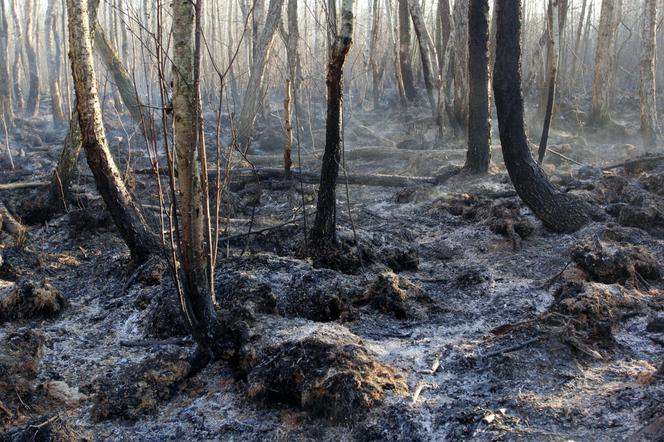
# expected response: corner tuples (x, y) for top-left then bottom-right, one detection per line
(639, 0), (658, 149)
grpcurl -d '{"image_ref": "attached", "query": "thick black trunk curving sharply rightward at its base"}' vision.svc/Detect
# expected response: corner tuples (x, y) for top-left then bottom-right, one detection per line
(493, 0), (590, 232)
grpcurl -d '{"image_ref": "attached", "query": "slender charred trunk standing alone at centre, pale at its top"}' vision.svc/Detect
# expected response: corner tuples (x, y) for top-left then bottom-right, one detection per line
(311, 0), (354, 250)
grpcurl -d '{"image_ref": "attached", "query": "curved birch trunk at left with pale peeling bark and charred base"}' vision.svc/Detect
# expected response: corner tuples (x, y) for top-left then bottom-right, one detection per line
(67, 0), (158, 262)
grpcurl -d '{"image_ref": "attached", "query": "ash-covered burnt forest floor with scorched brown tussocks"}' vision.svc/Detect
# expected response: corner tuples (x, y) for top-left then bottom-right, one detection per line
(0, 97), (664, 441)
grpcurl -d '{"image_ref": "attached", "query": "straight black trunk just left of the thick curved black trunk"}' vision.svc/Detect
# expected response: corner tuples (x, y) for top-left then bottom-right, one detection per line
(465, 0), (491, 174)
